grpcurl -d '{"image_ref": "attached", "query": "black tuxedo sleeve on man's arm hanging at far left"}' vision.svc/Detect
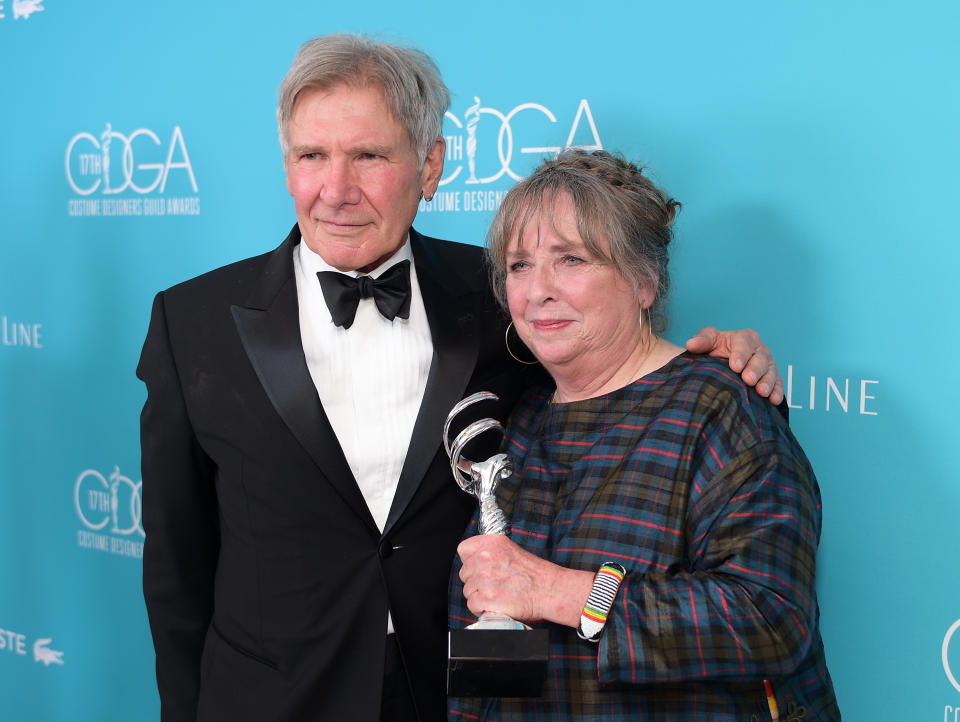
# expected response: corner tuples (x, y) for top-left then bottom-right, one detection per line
(137, 293), (219, 722)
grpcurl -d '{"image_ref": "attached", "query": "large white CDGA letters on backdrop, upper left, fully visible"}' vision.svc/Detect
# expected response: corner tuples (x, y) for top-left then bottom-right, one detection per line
(66, 123), (197, 196)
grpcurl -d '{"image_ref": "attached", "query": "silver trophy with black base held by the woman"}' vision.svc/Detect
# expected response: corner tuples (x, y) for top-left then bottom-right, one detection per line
(443, 391), (549, 697)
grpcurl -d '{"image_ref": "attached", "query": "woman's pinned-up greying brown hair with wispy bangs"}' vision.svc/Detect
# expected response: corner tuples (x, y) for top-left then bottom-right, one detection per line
(487, 148), (680, 332)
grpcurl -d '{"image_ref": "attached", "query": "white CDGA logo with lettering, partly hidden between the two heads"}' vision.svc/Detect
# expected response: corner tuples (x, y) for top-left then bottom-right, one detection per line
(419, 96), (603, 213)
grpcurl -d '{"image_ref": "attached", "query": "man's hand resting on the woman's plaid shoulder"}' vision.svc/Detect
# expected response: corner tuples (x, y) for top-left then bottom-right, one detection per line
(687, 326), (783, 404)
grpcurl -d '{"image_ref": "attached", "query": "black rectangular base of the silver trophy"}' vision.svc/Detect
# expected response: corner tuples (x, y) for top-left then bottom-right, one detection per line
(447, 629), (550, 697)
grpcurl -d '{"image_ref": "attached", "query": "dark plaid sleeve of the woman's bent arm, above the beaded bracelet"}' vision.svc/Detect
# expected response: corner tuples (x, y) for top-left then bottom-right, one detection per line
(598, 394), (820, 684)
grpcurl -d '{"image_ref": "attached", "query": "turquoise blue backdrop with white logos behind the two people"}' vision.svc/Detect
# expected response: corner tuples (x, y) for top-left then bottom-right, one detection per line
(0, 0), (960, 722)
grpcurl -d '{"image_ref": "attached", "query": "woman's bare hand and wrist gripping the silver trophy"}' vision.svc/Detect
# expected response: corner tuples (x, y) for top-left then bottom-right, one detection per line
(457, 534), (594, 628)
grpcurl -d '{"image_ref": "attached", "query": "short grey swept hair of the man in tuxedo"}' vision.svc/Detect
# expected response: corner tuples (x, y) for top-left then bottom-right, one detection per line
(277, 35), (450, 167)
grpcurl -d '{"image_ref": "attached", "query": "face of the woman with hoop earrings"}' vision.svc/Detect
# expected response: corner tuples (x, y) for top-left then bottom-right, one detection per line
(506, 195), (649, 381)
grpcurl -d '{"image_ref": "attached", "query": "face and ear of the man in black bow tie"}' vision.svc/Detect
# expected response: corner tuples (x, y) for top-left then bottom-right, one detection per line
(284, 85), (445, 271)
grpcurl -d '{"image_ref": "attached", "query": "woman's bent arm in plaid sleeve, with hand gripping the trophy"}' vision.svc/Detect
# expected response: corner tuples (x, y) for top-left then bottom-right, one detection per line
(458, 434), (820, 684)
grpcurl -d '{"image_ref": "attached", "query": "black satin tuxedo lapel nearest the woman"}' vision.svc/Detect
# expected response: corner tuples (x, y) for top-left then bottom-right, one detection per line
(384, 229), (479, 532)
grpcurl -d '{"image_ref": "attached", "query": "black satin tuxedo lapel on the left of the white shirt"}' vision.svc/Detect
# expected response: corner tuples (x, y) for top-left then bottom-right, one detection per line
(231, 227), (379, 533)
